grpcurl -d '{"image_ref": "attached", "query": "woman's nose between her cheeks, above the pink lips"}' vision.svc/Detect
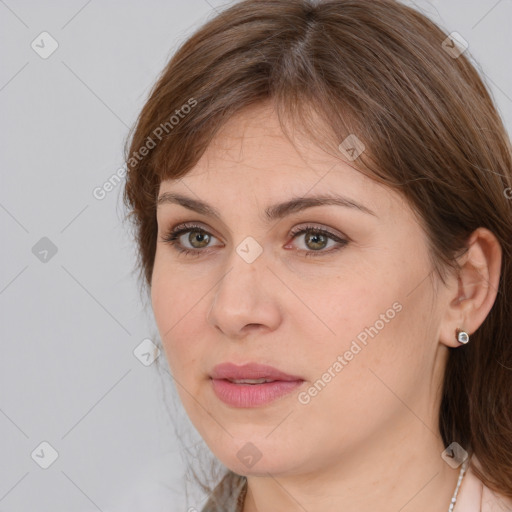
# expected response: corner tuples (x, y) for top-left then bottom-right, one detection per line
(207, 252), (281, 340)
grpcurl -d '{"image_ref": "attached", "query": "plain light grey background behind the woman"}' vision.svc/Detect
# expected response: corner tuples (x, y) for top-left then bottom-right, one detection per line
(0, 0), (512, 512)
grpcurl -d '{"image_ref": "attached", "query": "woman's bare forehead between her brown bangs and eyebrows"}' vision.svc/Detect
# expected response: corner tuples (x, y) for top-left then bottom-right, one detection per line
(160, 105), (407, 222)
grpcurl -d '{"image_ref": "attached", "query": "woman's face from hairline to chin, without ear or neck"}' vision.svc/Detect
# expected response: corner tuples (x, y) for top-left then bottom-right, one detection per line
(152, 107), (448, 475)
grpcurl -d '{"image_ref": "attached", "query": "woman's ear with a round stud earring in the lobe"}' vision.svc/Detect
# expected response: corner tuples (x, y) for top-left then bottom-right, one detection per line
(439, 227), (502, 347)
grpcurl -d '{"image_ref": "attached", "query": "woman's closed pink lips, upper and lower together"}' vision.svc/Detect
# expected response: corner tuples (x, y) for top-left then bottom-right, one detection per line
(210, 363), (304, 407)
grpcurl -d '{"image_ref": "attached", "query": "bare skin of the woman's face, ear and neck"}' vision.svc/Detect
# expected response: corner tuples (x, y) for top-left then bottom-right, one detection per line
(151, 102), (501, 512)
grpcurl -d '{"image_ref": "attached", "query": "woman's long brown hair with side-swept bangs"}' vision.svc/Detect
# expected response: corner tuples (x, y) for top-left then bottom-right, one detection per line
(124, 0), (512, 497)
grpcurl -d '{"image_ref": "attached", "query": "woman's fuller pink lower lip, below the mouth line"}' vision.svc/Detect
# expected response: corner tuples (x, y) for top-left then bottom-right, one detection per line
(211, 379), (304, 407)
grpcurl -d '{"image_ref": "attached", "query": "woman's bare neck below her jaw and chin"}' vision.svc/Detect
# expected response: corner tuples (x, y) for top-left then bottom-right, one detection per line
(243, 420), (460, 512)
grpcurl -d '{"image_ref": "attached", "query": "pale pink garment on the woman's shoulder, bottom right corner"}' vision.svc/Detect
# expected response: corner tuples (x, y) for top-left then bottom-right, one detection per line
(453, 456), (512, 512)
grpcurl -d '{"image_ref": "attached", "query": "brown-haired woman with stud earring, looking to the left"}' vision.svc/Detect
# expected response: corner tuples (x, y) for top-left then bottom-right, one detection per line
(125, 0), (512, 512)
